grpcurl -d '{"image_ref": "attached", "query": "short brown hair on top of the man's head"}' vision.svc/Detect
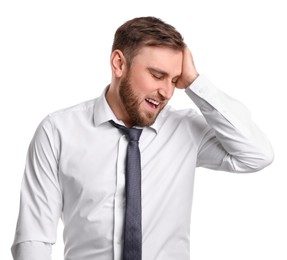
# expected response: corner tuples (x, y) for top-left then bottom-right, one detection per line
(112, 16), (185, 64)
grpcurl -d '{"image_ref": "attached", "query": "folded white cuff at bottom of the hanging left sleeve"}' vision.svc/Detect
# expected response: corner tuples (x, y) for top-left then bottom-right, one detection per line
(11, 241), (52, 260)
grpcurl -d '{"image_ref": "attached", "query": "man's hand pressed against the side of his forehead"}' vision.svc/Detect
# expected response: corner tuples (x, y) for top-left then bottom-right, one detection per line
(176, 47), (199, 89)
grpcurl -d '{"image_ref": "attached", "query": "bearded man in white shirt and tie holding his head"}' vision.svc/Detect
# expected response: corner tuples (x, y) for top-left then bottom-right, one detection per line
(12, 17), (273, 260)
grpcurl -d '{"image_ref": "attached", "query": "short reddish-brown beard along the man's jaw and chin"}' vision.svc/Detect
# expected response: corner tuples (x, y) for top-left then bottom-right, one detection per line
(119, 71), (163, 126)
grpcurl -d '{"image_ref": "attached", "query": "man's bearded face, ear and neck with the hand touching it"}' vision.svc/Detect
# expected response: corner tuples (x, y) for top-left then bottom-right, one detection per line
(106, 47), (199, 127)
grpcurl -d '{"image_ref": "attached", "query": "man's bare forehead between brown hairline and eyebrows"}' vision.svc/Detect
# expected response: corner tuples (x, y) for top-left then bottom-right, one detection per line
(132, 46), (183, 75)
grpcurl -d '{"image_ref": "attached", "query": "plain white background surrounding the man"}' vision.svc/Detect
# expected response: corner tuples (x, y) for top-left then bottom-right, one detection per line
(0, 0), (287, 260)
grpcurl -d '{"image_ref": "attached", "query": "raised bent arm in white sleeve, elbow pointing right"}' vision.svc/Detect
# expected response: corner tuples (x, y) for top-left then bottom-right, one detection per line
(186, 75), (273, 172)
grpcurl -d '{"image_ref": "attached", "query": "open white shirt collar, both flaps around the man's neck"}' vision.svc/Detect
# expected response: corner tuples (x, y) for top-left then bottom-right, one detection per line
(94, 85), (165, 133)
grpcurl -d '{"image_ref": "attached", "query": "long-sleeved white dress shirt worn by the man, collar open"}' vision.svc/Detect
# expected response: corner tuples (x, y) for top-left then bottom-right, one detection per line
(12, 75), (273, 260)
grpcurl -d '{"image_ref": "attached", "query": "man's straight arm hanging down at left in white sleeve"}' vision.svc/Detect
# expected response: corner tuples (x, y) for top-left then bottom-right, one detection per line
(11, 119), (62, 260)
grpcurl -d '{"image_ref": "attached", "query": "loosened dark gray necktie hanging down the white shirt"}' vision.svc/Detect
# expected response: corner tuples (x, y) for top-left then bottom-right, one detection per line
(110, 120), (142, 260)
